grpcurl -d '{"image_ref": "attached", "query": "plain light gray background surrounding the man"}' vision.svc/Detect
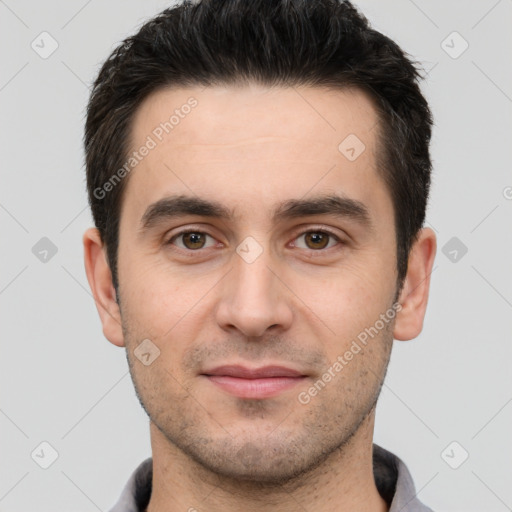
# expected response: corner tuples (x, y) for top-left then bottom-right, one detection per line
(0, 0), (512, 512)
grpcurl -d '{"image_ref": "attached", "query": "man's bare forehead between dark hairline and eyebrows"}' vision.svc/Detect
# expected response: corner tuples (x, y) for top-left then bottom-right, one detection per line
(125, 85), (385, 222)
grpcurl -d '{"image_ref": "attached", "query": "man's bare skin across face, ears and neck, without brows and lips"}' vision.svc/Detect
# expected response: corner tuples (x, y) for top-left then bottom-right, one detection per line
(84, 85), (436, 512)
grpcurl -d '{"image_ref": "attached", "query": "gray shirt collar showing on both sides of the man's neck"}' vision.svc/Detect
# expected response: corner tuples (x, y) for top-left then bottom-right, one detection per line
(110, 444), (433, 512)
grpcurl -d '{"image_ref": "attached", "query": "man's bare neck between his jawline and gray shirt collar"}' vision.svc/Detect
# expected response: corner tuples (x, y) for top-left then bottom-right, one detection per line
(147, 411), (388, 512)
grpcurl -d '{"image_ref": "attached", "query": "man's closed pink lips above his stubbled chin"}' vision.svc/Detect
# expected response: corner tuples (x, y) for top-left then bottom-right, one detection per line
(201, 365), (308, 399)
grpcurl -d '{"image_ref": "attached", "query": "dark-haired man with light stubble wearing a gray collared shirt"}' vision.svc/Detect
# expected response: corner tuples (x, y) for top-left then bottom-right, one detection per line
(84, 0), (436, 512)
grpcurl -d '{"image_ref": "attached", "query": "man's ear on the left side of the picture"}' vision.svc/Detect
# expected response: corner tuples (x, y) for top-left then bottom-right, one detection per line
(83, 228), (124, 347)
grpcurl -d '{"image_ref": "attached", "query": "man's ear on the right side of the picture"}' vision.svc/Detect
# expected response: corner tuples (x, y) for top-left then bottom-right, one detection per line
(393, 228), (436, 341)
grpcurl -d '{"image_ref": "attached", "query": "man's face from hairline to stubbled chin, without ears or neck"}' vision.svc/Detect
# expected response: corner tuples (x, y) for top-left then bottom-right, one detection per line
(118, 86), (397, 482)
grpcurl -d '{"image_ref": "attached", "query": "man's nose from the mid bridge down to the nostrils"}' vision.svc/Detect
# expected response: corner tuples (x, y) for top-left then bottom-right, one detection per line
(216, 249), (293, 338)
